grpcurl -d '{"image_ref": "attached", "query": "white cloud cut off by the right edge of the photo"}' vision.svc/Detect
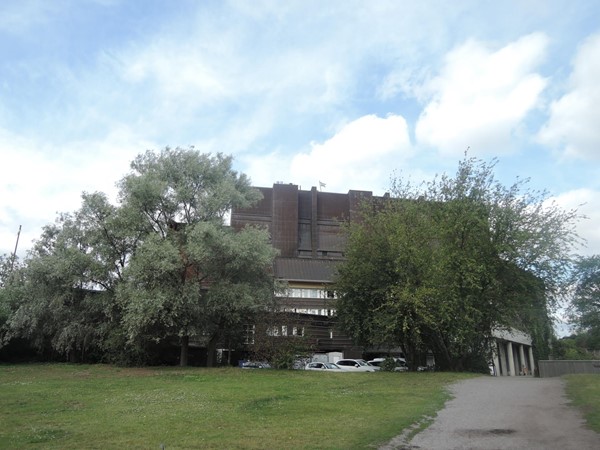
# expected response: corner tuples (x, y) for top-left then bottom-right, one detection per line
(538, 34), (600, 160)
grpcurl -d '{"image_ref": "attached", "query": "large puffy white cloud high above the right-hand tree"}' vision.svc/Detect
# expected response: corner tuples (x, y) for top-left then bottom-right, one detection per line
(416, 33), (548, 155)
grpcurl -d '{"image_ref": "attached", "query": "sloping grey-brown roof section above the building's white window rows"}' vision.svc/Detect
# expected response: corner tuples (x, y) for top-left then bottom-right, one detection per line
(275, 258), (340, 283)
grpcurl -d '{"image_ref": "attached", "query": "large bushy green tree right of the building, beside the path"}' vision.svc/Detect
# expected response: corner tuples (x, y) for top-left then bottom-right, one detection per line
(336, 157), (578, 370)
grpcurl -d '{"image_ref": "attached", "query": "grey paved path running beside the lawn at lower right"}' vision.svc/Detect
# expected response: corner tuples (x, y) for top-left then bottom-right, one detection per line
(381, 377), (600, 450)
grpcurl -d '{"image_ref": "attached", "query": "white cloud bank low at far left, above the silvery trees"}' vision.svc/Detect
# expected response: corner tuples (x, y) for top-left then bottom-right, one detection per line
(0, 126), (156, 254)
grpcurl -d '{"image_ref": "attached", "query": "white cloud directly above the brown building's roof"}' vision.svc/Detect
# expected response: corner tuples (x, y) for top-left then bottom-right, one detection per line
(290, 115), (413, 192)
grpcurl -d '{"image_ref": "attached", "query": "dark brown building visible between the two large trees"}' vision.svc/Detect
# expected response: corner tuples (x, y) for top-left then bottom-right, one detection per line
(231, 183), (380, 357)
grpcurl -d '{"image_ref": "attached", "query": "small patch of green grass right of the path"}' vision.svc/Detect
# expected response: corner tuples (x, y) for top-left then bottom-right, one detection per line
(564, 374), (600, 433)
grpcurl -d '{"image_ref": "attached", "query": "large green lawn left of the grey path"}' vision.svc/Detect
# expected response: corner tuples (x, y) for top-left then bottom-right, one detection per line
(0, 364), (474, 450)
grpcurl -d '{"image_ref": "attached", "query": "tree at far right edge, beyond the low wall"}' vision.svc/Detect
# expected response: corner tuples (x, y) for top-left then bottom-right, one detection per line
(570, 255), (600, 350)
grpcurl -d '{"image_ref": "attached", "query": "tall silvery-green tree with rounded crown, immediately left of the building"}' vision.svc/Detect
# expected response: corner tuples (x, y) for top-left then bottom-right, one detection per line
(118, 148), (275, 365)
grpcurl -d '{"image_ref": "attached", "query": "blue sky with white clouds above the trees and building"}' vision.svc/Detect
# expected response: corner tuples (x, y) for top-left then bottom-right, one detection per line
(0, 0), (600, 260)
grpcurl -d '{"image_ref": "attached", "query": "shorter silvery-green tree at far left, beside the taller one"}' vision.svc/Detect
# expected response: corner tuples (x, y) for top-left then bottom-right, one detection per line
(4, 193), (135, 360)
